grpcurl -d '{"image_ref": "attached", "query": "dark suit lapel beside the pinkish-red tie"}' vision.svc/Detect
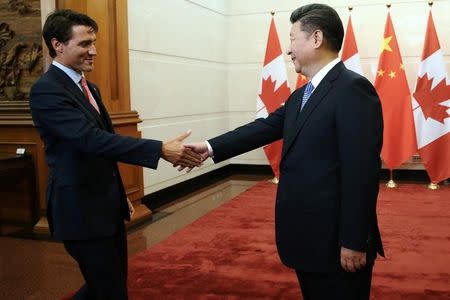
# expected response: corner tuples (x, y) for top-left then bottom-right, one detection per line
(48, 65), (106, 129)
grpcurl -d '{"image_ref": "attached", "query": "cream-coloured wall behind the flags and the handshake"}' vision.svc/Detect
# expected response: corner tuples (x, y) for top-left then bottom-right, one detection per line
(128, 0), (450, 194)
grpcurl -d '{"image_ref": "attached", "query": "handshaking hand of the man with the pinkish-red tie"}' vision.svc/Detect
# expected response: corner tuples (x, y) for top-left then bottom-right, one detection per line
(161, 130), (203, 169)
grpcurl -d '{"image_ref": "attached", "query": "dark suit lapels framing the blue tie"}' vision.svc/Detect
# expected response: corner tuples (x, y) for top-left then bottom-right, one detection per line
(282, 62), (344, 158)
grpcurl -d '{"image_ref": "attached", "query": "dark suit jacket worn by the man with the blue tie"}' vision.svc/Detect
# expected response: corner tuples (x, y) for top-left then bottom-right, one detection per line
(209, 62), (383, 272)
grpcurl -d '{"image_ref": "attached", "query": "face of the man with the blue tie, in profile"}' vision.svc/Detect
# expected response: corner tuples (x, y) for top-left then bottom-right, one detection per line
(287, 21), (315, 76)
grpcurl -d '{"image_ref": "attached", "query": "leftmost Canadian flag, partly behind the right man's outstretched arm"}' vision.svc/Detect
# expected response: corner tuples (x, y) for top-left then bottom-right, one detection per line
(256, 18), (291, 178)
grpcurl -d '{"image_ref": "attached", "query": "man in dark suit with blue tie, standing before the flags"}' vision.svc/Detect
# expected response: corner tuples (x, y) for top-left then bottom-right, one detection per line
(185, 4), (383, 300)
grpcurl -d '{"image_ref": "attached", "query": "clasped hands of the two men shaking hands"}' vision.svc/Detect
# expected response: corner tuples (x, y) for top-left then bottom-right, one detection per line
(161, 130), (209, 172)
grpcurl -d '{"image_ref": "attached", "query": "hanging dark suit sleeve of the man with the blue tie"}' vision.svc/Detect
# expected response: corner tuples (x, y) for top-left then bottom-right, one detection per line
(336, 78), (383, 251)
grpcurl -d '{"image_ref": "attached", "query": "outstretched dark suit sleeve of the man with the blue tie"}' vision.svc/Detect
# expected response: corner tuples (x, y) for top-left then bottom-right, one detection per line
(208, 105), (285, 163)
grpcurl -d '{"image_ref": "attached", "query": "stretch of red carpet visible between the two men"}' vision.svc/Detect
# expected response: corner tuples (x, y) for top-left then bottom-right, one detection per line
(128, 182), (299, 299)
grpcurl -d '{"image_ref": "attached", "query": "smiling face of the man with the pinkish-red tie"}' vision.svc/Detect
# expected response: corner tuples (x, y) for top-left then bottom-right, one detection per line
(52, 25), (97, 73)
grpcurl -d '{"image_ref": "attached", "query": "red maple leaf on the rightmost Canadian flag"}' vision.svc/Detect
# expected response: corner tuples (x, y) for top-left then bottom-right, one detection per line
(413, 74), (450, 123)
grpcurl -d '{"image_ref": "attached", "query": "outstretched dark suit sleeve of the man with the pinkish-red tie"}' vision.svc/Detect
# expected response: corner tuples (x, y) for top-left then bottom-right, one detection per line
(30, 82), (162, 169)
